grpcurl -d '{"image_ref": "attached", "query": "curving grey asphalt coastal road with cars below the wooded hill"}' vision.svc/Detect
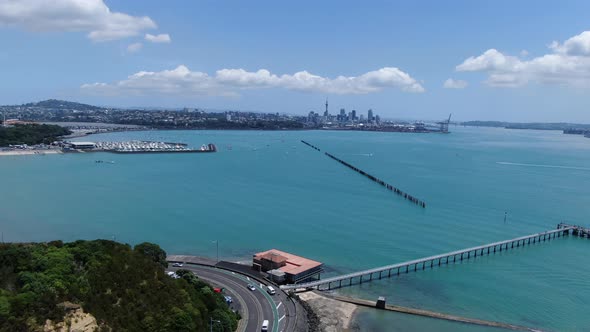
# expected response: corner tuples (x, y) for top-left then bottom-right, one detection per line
(169, 264), (289, 332)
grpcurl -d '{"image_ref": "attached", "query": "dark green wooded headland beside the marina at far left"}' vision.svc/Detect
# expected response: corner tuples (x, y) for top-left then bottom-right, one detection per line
(0, 124), (70, 146)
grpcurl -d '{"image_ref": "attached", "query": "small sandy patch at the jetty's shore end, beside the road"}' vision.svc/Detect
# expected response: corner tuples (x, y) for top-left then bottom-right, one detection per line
(297, 292), (358, 332)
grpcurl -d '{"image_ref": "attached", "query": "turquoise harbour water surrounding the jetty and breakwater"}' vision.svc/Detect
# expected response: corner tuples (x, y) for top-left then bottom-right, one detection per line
(0, 127), (590, 331)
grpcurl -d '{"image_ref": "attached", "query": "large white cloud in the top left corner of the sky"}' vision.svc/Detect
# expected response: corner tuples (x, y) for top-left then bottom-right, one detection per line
(0, 0), (156, 41)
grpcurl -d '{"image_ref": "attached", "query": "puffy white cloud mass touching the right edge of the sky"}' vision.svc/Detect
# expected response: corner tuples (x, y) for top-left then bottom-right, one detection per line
(456, 31), (590, 87)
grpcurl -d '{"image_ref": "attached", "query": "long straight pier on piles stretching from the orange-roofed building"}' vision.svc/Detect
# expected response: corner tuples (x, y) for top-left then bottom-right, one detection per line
(281, 223), (590, 290)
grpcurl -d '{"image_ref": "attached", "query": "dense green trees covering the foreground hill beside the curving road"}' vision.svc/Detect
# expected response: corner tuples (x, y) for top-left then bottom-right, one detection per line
(0, 240), (238, 332)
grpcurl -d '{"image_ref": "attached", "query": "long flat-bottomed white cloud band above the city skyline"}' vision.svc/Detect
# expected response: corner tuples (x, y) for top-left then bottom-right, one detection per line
(81, 65), (424, 96)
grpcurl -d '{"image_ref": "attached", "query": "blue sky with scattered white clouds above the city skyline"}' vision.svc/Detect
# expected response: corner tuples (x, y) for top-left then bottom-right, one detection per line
(0, 0), (590, 123)
